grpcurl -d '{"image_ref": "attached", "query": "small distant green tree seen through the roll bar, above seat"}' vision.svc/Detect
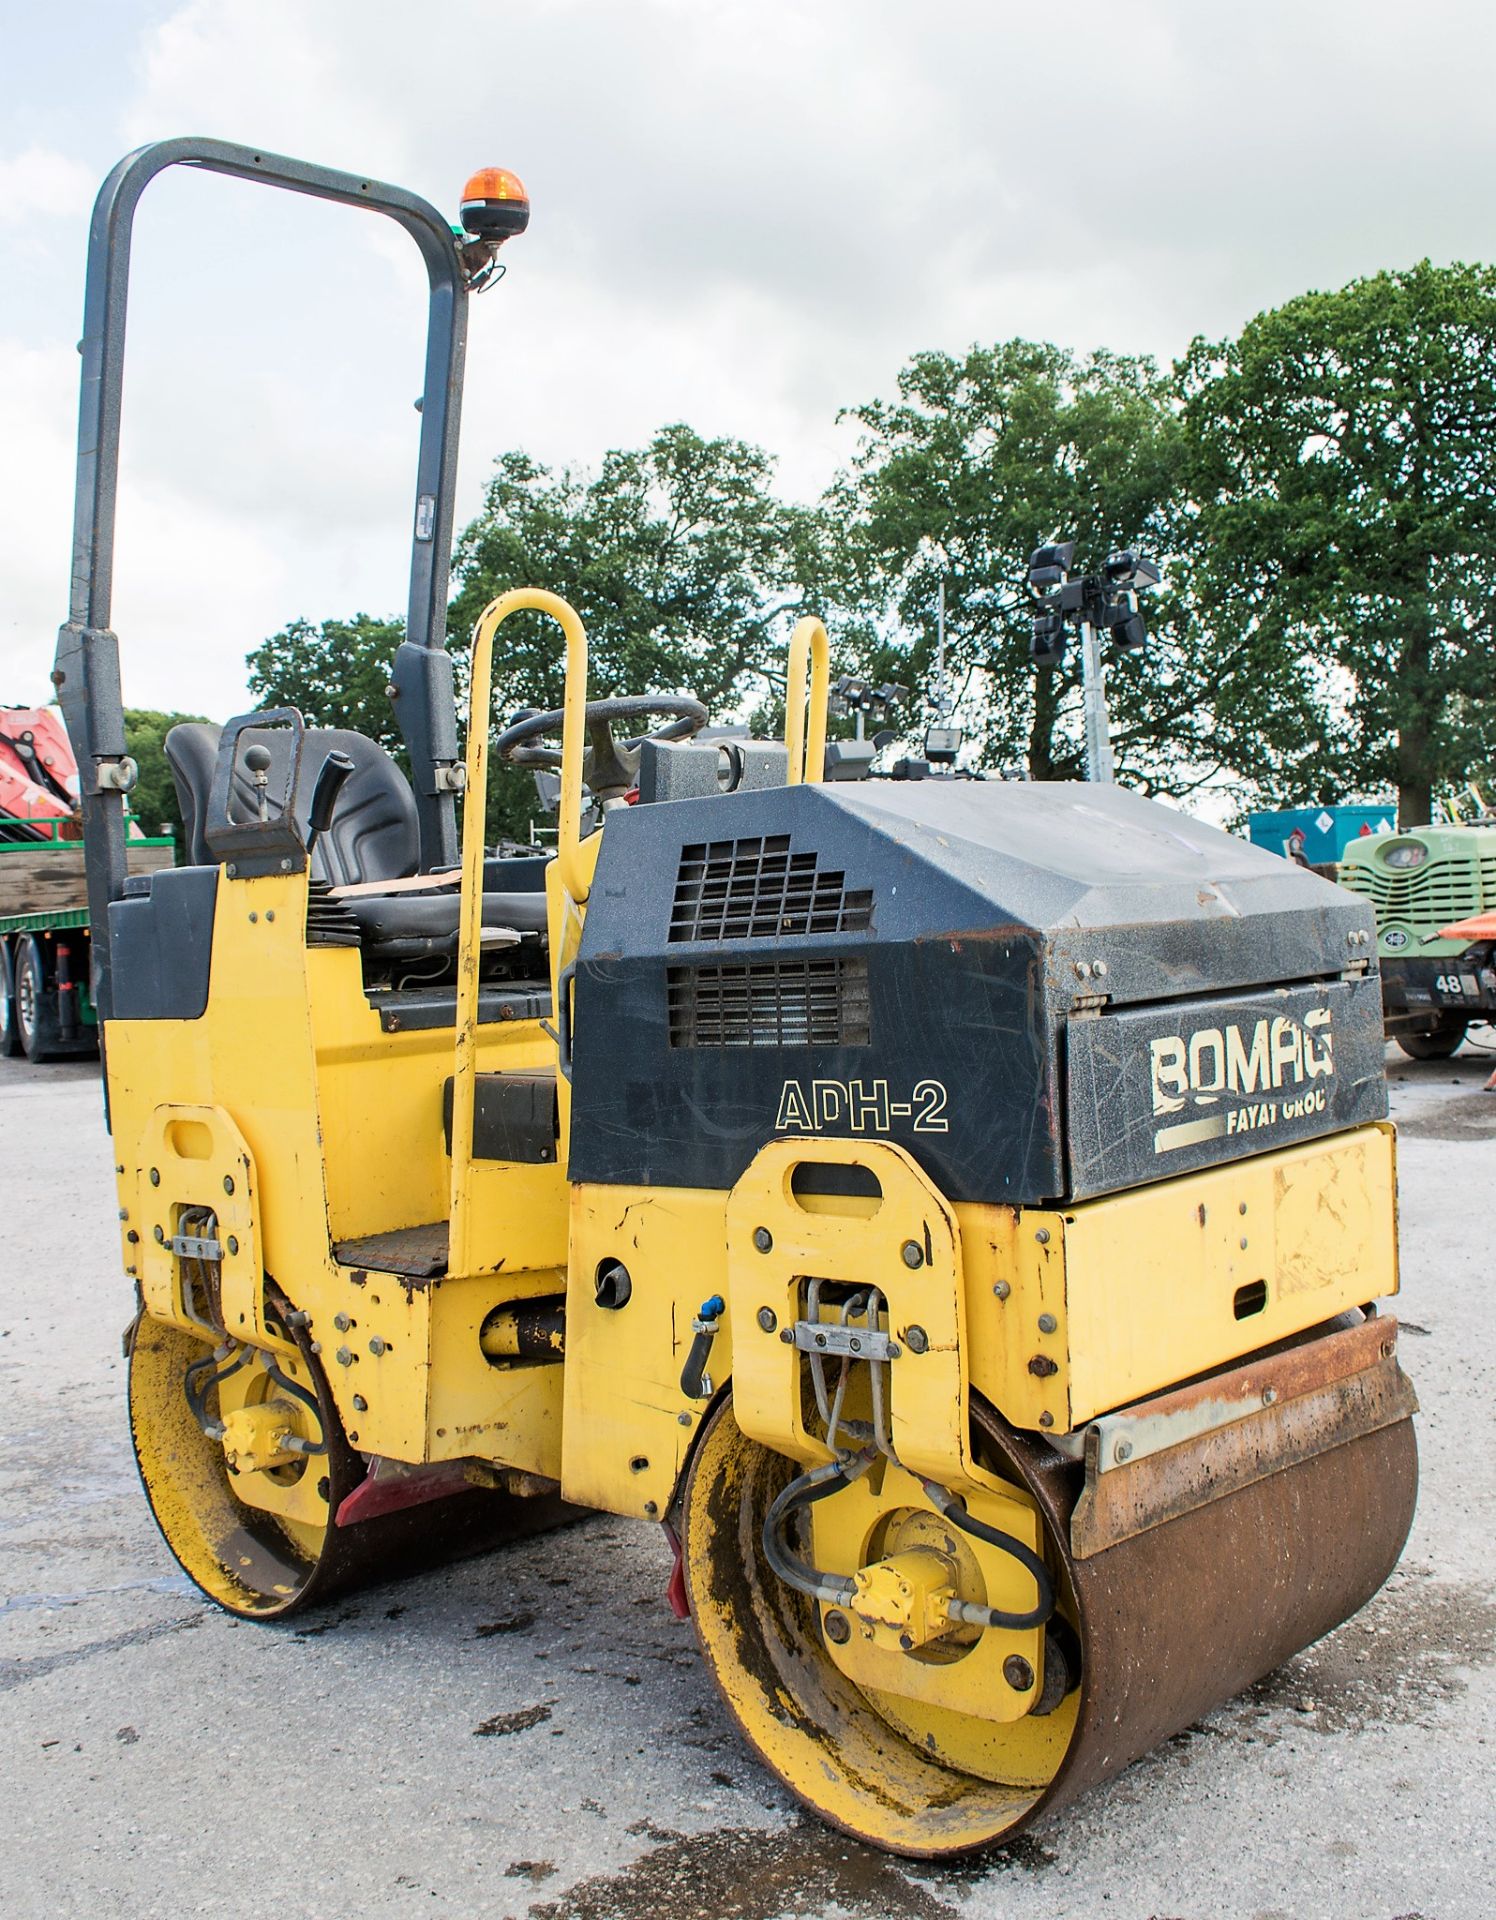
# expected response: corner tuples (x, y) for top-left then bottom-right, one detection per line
(246, 612), (409, 772)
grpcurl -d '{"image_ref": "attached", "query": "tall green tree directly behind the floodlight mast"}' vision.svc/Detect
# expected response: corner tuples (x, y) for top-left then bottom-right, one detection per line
(820, 340), (1219, 793)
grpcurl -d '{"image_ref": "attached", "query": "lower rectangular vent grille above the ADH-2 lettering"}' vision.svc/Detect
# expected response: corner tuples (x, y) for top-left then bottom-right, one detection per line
(668, 958), (872, 1046)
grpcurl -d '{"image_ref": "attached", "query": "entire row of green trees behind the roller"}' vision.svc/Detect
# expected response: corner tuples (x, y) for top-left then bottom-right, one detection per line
(250, 261), (1496, 831)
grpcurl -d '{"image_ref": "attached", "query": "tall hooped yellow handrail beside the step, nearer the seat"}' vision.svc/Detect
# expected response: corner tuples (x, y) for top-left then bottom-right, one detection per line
(447, 588), (588, 1273)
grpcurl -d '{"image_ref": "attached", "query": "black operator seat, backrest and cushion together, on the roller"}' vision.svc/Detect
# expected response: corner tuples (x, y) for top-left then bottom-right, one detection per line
(163, 720), (545, 954)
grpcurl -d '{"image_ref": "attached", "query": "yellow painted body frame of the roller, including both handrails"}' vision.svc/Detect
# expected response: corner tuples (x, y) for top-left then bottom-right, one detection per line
(109, 606), (1396, 1515)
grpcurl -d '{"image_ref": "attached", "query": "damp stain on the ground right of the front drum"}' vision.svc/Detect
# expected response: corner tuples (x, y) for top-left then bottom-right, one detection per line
(1239, 1576), (1496, 1738)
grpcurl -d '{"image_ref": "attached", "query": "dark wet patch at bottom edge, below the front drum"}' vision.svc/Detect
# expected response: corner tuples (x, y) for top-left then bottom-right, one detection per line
(530, 1820), (958, 1920)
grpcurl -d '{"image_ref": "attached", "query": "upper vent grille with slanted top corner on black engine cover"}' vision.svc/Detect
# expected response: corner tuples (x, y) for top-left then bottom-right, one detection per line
(670, 833), (872, 943)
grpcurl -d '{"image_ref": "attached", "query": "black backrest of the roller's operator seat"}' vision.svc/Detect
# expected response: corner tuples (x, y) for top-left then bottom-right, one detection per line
(165, 720), (421, 887)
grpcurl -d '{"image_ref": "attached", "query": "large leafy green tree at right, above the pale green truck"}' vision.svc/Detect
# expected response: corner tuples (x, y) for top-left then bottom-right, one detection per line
(1179, 261), (1496, 826)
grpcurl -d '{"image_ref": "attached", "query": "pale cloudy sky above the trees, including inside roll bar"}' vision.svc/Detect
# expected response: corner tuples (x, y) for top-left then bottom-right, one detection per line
(0, 0), (1496, 716)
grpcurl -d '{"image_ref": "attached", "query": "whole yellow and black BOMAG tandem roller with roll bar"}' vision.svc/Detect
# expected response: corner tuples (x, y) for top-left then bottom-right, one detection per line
(58, 140), (1415, 1857)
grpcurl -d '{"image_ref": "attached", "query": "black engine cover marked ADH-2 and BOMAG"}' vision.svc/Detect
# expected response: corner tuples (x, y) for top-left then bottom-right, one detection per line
(570, 780), (1387, 1206)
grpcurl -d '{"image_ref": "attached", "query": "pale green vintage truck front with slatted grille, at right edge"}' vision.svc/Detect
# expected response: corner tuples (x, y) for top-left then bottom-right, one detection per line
(1340, 816), (1496, 1060)
